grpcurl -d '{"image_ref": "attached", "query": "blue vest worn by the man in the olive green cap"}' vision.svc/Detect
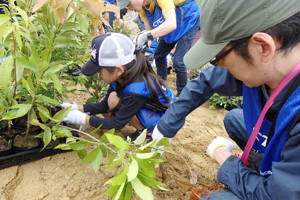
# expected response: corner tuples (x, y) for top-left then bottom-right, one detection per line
(243, 85), (300, 177)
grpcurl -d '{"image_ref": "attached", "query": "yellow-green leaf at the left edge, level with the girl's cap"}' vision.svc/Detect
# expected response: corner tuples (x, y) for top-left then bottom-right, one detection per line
(0, 56), (14, 90)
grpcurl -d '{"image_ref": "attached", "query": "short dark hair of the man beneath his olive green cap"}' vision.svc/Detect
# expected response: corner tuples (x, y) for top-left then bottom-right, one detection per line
(229, 12), (300, 63)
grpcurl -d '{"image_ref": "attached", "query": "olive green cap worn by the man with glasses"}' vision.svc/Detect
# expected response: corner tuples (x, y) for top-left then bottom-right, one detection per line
(183, 0), (300, 69)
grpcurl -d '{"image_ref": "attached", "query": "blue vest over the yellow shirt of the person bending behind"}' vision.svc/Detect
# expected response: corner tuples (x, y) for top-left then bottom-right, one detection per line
(143, 0), (200, 44)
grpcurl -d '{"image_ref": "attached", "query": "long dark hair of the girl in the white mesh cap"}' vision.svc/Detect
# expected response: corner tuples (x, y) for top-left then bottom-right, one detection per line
(106, 51), (172, 117)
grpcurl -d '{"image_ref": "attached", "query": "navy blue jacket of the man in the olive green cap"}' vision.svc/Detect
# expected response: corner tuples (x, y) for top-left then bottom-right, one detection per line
(157, 66), (300, 200)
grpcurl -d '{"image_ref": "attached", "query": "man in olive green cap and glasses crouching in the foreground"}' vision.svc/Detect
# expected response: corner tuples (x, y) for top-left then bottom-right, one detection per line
(152, 0), (300, 200)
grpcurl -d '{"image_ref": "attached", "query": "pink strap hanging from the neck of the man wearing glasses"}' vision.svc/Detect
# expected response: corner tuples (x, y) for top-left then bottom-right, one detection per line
(242, 62), (300, 167)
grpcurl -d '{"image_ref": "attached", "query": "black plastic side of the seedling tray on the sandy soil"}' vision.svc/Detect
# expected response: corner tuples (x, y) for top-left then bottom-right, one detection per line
(0, 148), (72, 169)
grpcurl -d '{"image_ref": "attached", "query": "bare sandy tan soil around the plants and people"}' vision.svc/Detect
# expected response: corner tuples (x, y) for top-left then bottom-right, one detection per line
(0, 12), (239, 200)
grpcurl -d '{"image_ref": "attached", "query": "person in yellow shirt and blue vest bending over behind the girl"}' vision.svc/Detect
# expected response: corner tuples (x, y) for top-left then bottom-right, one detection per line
(117, 0), (200, 96)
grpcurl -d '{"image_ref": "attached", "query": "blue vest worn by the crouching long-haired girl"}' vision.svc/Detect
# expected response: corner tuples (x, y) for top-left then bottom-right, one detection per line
(111, 81), (176, 130)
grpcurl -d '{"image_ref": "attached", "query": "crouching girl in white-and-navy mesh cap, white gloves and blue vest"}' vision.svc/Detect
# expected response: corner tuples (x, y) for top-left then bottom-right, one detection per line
(61, 33), (176, 140)
